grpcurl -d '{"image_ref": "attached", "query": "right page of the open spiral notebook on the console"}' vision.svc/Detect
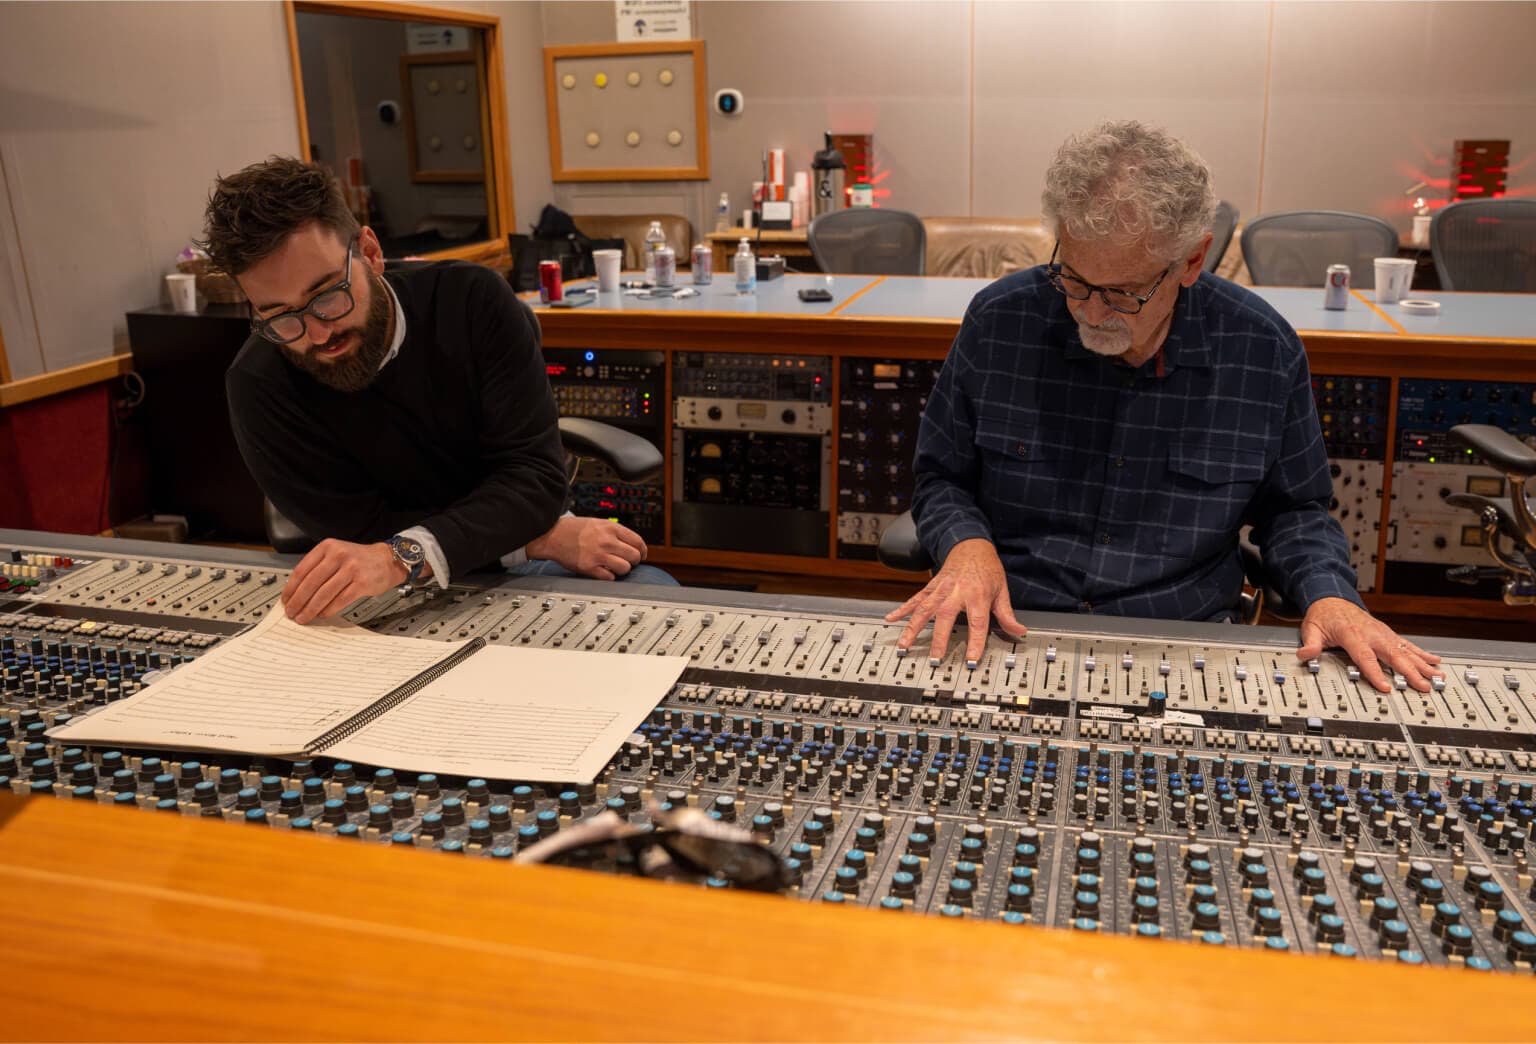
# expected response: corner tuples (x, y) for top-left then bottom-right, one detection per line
(326, 645), (688, 783)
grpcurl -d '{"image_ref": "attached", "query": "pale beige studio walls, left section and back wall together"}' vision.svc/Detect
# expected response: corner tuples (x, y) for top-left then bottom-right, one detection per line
(0, 0), (1536, 378)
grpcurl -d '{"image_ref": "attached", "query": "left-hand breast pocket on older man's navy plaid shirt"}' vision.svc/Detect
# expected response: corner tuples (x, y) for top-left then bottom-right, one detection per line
(975, 427), (1086, 543)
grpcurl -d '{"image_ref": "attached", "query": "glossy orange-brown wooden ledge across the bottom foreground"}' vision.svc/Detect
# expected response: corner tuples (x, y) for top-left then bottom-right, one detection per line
(0, 795), (1536, 1041)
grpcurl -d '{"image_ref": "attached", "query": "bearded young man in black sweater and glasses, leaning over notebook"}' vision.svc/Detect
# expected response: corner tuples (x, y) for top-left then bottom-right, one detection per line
(206, 157), (673, 623)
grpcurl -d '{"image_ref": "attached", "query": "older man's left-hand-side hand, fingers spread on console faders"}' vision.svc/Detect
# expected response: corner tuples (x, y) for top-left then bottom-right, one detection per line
(885, 539), (1026, 663)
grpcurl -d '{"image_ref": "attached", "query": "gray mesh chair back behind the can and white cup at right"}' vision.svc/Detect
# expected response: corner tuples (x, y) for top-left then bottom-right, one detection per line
(1243, 210), (1398, 290)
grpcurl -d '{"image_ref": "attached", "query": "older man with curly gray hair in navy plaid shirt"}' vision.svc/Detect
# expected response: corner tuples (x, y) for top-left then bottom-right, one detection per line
(888, 121), (1439, 691)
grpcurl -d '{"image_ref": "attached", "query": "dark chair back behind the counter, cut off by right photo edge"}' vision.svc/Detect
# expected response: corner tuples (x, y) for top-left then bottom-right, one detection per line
(1430, 200), (1536, 293)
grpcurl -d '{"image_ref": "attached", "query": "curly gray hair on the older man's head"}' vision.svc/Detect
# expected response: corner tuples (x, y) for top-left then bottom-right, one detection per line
(1040, 120), (1217, 263)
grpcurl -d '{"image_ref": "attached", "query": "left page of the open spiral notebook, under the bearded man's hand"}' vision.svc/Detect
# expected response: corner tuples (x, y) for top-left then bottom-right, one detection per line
(49, 606), (460, 755)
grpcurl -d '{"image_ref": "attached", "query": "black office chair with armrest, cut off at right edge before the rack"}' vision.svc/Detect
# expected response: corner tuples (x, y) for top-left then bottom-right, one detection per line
(1445, 420), (1536, 605)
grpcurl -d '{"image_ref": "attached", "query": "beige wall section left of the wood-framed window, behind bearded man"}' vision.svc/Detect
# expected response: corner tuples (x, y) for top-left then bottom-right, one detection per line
(0, 3), (298, 379)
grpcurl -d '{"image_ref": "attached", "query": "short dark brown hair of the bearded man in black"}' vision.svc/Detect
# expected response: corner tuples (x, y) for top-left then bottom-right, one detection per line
(201, 157), (358, 276)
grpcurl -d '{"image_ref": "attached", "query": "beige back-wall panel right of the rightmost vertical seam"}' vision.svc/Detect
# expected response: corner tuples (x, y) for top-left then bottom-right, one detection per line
(1263, 3), (1536, 232)
